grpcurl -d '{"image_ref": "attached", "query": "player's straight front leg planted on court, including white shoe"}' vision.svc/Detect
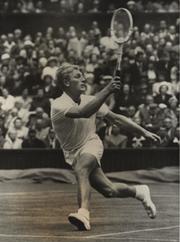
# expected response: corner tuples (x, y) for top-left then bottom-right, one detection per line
(68, 153), (97, 230)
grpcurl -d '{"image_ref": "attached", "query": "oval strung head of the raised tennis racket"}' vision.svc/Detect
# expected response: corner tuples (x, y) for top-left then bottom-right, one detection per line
(111, 8), (133, 44)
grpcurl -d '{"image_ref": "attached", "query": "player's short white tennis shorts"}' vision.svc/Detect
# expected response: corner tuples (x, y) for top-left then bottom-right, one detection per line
(63, 135), (104, 166)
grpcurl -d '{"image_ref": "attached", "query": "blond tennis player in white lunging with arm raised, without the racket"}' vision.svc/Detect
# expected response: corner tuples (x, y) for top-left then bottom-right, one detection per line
(51, 63), (159, 230)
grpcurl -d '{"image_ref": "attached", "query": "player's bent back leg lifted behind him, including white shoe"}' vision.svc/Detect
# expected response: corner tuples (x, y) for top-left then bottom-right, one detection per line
(90, 167), (156, 218)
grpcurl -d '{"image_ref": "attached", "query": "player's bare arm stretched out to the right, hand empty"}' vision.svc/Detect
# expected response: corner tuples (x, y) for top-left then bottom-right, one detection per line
(105, 111), (161, 142)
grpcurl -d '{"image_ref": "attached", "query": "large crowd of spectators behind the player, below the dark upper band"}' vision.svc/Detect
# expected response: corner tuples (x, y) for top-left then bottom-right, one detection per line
(0, 17), (180, 149)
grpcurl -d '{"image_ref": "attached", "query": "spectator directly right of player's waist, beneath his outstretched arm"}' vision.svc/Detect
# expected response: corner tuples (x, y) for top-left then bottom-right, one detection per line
(104, 125), (127, 148)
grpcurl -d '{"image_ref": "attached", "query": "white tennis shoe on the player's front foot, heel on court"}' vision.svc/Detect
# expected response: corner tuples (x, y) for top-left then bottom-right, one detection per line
(68, 211), (91, 231)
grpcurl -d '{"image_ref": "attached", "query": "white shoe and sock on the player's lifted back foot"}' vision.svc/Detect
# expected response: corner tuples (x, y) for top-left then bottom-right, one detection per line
(135, 185), (156, 219)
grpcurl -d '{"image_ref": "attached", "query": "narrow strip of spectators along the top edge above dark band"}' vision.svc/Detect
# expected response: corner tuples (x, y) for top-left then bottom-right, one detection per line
(0, 0), (179, 14)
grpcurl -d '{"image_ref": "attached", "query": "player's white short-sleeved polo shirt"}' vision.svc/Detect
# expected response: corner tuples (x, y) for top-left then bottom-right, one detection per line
(51, 93), (109, 151)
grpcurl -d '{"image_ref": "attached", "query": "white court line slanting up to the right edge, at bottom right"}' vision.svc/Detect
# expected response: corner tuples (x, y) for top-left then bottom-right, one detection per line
(87, 225), (180, 239)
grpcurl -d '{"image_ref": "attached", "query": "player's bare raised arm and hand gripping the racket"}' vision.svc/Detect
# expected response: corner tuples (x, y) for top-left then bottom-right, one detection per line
(65, 77), (121, 118)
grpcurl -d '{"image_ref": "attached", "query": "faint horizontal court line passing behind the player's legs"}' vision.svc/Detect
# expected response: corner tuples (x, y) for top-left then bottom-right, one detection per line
(0, 190), (179, 198)
